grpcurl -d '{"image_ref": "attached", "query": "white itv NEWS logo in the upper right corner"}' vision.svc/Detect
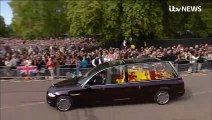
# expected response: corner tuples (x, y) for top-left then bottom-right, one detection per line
(169, 5), (202, 12)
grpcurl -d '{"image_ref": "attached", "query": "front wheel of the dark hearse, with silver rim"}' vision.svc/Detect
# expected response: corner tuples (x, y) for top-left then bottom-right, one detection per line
(56, 96), (72, 111)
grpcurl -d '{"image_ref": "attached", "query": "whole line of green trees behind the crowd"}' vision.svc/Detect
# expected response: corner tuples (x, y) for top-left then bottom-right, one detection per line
(2, 0), (212, 41)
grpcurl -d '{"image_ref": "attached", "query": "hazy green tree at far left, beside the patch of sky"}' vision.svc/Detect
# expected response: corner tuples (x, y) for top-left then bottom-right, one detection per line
(10, 0), (67, 39)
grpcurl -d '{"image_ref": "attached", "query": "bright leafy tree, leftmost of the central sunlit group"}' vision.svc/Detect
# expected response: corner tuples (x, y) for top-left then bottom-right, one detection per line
(67, 0), (101, 36)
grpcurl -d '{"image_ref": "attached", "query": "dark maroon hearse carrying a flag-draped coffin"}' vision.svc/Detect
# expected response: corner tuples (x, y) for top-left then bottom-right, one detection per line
(46, 58), (185, 111)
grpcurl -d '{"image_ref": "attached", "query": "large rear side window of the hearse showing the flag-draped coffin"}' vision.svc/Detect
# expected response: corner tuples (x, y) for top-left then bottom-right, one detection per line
(127, 62), (176, 82)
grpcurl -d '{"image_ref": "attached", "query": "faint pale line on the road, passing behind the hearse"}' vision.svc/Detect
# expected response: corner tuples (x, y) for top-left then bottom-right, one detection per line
(0, 90), (212, 110)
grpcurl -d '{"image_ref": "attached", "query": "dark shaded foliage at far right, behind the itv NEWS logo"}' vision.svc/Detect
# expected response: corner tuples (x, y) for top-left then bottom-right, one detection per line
(161, 0), (212, 38)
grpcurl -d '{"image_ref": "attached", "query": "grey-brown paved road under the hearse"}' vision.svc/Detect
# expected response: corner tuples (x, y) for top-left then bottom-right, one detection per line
(0, 73), (212, 120)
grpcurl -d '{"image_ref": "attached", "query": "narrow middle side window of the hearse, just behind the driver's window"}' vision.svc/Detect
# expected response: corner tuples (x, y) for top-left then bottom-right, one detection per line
(108, 65), (125, 84)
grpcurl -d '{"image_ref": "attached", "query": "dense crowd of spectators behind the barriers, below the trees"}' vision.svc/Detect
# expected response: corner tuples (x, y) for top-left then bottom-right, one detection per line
(0, 38), (212, 76)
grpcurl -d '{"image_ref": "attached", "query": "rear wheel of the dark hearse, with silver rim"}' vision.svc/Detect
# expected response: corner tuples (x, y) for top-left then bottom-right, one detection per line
(154, 90), (170, 105)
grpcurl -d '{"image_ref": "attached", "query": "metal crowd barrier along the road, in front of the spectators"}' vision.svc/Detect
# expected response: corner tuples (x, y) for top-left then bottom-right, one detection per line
(0, 62), (212, 79)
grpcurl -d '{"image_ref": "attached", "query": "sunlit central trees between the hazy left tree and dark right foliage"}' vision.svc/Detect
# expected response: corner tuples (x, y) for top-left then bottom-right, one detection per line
(67, 0), (163, 41)
